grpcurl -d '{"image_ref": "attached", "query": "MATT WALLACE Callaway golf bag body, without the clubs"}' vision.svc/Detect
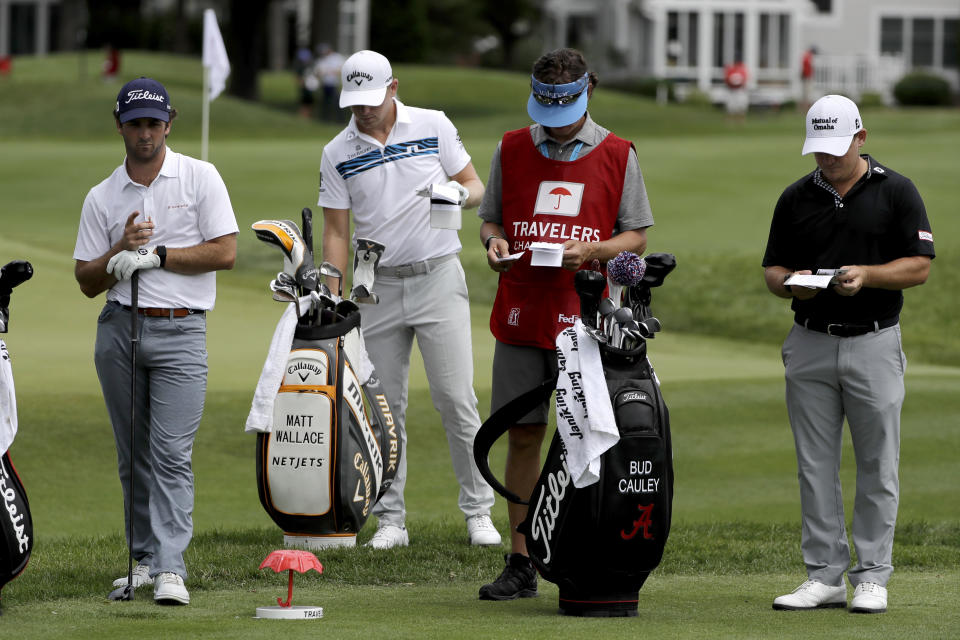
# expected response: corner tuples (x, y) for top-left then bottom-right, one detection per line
(256, 311), (401, 549)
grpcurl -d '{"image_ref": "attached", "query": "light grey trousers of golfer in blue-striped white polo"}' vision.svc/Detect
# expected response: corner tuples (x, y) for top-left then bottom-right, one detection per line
(361, 259), (494, 526)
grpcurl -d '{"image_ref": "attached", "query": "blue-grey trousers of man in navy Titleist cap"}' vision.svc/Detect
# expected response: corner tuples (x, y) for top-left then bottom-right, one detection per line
(94, 302), (207, 578)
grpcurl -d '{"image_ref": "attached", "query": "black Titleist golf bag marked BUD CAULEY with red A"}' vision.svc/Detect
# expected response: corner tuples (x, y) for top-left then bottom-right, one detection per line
(474, 256), (673, 616)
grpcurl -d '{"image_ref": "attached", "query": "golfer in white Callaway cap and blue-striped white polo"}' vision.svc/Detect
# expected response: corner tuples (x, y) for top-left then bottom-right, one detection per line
(317, 51), (500, 549)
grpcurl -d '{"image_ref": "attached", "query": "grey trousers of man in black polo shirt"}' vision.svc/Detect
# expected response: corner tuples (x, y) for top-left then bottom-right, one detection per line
(783, 324), (907, 586)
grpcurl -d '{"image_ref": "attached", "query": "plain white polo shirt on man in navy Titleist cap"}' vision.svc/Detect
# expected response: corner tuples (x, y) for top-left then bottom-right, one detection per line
(73, 147), (238, 309)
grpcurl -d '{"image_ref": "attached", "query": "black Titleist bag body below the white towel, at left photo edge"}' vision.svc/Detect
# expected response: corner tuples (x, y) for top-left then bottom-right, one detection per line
(0, 451), (33, 604)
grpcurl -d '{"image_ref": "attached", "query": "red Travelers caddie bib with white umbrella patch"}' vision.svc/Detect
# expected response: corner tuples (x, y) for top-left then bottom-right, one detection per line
(490, 129), (633, 350)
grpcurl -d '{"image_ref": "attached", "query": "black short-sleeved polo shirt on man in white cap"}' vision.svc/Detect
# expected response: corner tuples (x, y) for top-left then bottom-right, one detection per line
(763, 155), (935, 324)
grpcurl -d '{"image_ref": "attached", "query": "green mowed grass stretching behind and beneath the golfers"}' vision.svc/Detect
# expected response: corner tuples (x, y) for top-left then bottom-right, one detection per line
(0, 54), (960, 638)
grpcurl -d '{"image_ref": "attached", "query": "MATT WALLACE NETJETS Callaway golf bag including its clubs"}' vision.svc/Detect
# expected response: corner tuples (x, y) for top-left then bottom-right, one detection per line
(247, 209), (401, 548)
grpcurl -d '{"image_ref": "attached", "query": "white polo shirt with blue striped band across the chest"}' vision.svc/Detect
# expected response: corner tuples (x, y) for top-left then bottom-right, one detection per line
(317, 99), (470, 267)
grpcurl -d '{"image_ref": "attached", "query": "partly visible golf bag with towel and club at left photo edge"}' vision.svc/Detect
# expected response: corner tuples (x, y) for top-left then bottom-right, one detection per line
(0, 260), (33, 616)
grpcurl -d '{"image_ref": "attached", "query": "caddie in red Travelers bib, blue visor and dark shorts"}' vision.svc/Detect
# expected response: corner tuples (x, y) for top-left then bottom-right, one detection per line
(477, 49), (653, 600)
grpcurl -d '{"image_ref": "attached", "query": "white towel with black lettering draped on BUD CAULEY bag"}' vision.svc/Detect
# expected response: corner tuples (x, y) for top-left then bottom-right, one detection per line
(556, 320), (620, 488)
